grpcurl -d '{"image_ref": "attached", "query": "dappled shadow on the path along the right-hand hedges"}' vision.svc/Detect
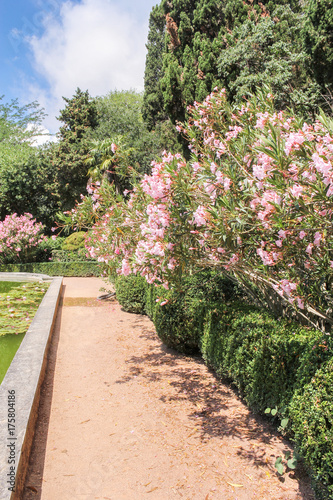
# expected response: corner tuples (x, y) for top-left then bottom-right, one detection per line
(116, 319), (315, 500)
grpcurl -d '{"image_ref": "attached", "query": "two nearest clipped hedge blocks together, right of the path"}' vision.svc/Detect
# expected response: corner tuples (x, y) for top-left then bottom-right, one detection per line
(201, 302), (333, 494)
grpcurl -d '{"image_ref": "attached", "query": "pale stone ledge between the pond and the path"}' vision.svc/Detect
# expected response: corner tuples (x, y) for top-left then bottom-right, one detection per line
(0, 277), (62, 500)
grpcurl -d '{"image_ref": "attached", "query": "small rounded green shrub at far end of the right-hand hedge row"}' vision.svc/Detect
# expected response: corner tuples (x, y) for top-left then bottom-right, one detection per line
(113, 274), (147, 314)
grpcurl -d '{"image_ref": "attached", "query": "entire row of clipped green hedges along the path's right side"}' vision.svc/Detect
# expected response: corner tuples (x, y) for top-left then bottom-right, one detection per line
(115, 271), (333, 499)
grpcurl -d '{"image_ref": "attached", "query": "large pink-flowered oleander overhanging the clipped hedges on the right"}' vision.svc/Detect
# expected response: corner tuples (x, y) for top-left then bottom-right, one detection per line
(70, 90), (333, 322)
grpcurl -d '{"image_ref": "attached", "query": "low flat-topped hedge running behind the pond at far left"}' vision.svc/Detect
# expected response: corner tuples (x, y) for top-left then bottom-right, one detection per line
(0, 261), (101, 277)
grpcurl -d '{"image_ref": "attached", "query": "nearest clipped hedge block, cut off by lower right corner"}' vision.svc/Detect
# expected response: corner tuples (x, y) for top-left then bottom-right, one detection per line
(289, 357), (333, 500)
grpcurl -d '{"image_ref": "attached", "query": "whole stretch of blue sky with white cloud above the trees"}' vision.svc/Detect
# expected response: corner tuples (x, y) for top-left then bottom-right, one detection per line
(0, 0), (159, 137)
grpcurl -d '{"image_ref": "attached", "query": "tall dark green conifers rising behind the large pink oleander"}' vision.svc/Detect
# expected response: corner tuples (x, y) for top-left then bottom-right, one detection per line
(143, 0), (333, 126)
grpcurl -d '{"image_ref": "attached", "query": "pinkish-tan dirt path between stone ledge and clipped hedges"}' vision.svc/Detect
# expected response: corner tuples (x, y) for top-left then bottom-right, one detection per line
(24, 278), (314, 500)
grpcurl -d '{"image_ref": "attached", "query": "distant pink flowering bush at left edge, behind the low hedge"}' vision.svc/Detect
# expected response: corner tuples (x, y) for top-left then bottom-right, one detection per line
(0, 213), (46, 264)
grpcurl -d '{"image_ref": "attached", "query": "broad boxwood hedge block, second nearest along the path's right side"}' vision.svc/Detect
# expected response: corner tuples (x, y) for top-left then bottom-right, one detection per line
(201, 302), (332, 417)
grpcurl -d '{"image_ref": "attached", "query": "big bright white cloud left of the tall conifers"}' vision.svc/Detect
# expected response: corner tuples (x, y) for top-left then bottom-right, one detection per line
(28, 0), (149, 131)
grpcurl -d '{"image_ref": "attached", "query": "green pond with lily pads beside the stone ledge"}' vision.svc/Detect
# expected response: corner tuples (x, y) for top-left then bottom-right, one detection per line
(0, 281), (49, 383)
